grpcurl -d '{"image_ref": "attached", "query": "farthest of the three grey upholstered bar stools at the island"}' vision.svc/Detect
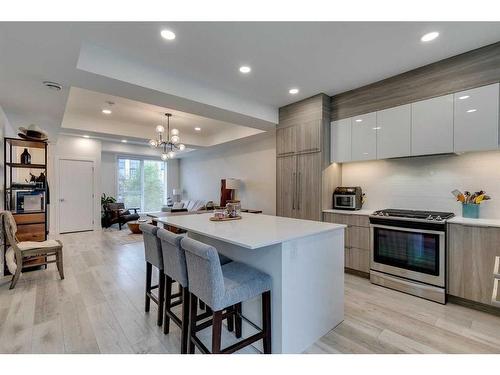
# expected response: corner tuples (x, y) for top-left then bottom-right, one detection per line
(139, 224), (165, 326)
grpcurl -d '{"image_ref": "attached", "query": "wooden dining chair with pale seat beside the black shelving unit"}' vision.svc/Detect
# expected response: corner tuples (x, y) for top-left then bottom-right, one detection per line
(1, 211), (64, 289)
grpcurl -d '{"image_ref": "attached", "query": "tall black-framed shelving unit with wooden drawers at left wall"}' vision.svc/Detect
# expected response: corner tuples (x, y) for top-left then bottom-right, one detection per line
(3, 138), (48, 274)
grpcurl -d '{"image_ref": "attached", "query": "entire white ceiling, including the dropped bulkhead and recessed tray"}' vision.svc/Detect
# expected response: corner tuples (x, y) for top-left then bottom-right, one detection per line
(0, 22), (500, 151)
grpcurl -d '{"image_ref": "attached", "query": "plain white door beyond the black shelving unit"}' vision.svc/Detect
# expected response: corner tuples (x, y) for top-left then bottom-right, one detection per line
(59, 159), (94, 233)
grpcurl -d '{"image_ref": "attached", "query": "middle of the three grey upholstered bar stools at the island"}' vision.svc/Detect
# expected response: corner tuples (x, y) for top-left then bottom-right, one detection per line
(157, 228), (241, 354)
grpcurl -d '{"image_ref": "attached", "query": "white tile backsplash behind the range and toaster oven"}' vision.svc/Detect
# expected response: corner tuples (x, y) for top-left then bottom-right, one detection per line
(342, 151), (500, 219)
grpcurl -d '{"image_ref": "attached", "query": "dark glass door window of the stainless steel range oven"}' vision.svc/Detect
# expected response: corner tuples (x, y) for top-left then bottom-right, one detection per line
(373, 228), (439, 276)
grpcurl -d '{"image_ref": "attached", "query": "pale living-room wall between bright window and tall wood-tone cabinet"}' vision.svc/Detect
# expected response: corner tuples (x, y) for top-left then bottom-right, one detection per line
(179, 132), (276, 215)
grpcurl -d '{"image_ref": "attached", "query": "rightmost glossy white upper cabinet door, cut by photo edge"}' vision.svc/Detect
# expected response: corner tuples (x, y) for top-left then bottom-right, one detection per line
(454, 83), (499, 152)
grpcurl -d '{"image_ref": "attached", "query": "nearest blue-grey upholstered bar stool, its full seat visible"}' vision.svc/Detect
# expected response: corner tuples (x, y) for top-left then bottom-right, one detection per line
(181, 237), (272, 354)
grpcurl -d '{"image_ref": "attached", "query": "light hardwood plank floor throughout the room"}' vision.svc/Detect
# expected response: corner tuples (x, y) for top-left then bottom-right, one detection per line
(0, 228), (500, 353)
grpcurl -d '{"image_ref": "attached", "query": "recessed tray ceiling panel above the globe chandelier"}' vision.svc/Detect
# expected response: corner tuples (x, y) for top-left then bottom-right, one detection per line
(61, 87), (262, 147)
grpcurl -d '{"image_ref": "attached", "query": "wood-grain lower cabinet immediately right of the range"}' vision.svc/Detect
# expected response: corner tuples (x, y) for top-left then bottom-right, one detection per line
(447, 224), (500, 305)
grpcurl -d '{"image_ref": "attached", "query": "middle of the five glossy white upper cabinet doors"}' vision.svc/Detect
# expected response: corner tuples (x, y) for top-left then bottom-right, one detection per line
(376, 104), (411, 159)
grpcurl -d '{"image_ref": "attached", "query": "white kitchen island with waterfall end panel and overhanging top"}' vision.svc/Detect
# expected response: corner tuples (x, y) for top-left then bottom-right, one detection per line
(158, 213), (345, 353)
